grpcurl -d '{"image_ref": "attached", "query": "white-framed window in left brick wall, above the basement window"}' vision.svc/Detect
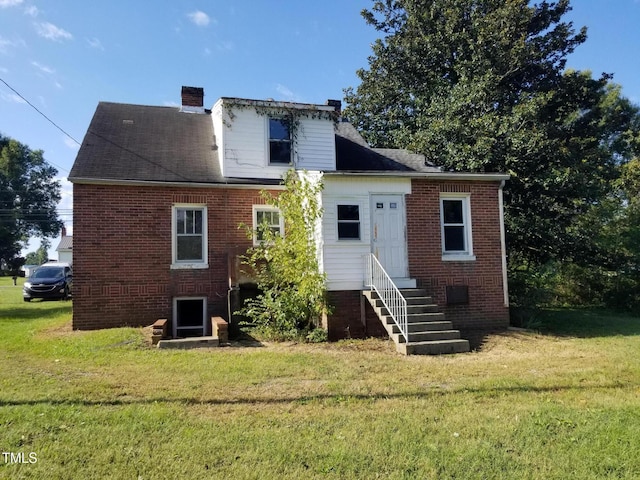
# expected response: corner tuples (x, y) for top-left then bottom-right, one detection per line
(171, 205), (208, 268)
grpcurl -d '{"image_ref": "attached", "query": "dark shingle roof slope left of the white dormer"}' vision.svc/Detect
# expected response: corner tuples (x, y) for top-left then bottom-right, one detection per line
(69, 102), (272, 183)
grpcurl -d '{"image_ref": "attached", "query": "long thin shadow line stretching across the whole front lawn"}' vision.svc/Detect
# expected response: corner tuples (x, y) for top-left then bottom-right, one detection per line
(0, 382), (640, 407)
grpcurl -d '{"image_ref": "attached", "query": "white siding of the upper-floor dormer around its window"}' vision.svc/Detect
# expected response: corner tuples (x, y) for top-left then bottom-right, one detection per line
(213, 102), (335, 179)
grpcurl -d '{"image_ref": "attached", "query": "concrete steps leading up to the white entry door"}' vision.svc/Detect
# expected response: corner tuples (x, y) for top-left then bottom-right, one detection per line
(362, 288), (470, 355)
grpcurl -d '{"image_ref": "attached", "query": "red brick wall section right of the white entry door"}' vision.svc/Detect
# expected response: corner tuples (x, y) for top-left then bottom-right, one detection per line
(407, 179), (509, 335)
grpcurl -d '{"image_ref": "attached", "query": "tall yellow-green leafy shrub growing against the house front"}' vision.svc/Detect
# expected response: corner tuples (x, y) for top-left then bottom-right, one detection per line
(238, 170), (328, 338)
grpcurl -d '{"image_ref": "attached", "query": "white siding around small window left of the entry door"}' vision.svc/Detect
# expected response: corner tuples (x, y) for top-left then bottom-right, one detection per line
(322, 175), (411, 290)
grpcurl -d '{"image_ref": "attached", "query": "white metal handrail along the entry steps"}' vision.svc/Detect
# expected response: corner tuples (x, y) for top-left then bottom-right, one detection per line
(366, 253), (409, 342)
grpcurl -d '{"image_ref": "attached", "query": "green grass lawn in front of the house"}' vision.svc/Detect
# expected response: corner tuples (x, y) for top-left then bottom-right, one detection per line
(0, 277), (640, 480)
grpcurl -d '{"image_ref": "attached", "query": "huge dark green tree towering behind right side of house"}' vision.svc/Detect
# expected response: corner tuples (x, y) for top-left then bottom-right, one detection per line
(344, 0), (638, 264)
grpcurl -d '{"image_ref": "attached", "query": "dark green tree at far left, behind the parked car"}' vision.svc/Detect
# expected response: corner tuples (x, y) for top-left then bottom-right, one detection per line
(0, 135), (62, 264)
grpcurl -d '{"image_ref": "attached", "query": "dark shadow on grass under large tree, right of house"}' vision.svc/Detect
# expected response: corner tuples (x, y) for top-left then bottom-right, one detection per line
(516, 308), (640, 338)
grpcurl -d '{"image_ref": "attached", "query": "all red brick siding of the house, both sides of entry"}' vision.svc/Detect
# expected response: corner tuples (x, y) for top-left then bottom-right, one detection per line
(73, 179), (509, 340)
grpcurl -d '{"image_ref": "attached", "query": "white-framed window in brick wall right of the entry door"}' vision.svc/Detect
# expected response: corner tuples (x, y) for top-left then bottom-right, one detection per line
(440, 194), (475, 261)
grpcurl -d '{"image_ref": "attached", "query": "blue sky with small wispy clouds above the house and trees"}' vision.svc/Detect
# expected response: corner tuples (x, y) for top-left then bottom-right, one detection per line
(0, 0), (640, 258)
